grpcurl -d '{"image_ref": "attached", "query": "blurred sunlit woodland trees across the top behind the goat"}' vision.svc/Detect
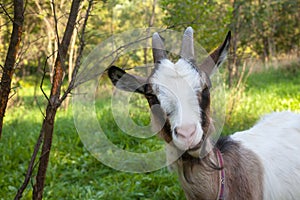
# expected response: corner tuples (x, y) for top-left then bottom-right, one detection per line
(0, 0), (300, 88)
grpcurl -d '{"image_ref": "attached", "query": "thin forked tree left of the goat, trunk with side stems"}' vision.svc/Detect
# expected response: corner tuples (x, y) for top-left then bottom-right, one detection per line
(15, 0), (93, 200)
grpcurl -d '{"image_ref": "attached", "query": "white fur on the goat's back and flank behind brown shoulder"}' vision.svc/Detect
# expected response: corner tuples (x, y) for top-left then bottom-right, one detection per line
(231, 112), (300, 200)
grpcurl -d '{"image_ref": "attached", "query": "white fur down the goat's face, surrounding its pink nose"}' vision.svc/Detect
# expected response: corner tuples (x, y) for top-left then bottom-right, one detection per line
(150, 59), (204, 150)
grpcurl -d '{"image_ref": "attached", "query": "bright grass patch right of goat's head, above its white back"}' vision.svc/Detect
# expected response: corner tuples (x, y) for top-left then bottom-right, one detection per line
(223, 63), (300, 134)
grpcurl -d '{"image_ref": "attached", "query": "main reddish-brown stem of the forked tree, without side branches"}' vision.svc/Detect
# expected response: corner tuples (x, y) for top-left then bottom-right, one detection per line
(32, 0), (80, 200)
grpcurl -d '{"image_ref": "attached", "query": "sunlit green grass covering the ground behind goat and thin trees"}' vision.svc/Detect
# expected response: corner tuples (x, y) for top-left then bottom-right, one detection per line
(0, 63), (300, 200)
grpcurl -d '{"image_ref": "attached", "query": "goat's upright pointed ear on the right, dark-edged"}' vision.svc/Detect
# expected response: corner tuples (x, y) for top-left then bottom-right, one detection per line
(199, 31), (231, 76)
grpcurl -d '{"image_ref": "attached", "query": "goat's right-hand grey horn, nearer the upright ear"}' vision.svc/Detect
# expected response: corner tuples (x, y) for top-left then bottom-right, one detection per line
(180, 27), (195, 60)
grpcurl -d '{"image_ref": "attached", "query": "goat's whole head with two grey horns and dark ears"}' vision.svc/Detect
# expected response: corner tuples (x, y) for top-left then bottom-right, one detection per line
(108, 27), (230, 156)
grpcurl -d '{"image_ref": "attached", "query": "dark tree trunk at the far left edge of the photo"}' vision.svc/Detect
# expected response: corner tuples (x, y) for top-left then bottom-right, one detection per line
(0, 0), (24, 137)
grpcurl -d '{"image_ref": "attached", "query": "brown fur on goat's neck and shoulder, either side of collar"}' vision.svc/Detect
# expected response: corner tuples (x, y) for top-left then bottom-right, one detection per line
(177, 137), (263, 200)
